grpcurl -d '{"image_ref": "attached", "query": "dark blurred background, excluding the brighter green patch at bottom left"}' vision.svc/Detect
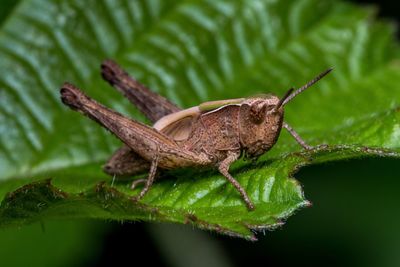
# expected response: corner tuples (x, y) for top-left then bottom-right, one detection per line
(93, 1), (400, 266)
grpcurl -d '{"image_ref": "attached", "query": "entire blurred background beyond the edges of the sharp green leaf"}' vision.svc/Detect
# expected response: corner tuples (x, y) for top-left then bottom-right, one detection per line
(0, 0), (400, 266)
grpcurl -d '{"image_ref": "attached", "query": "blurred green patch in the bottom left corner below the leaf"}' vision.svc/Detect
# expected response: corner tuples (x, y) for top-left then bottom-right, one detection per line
(0, 219), (105, 267)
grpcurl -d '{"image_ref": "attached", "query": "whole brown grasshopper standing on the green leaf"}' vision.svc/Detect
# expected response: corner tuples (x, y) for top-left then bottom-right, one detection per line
(60, 60), (332, 210)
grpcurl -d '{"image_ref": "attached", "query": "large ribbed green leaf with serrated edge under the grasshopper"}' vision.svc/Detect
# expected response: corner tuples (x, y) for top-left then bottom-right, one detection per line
(0, 0), (400, 239)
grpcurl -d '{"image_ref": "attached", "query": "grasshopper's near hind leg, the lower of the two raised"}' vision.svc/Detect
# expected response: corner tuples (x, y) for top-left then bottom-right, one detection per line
(60, 83), (212, 200)
